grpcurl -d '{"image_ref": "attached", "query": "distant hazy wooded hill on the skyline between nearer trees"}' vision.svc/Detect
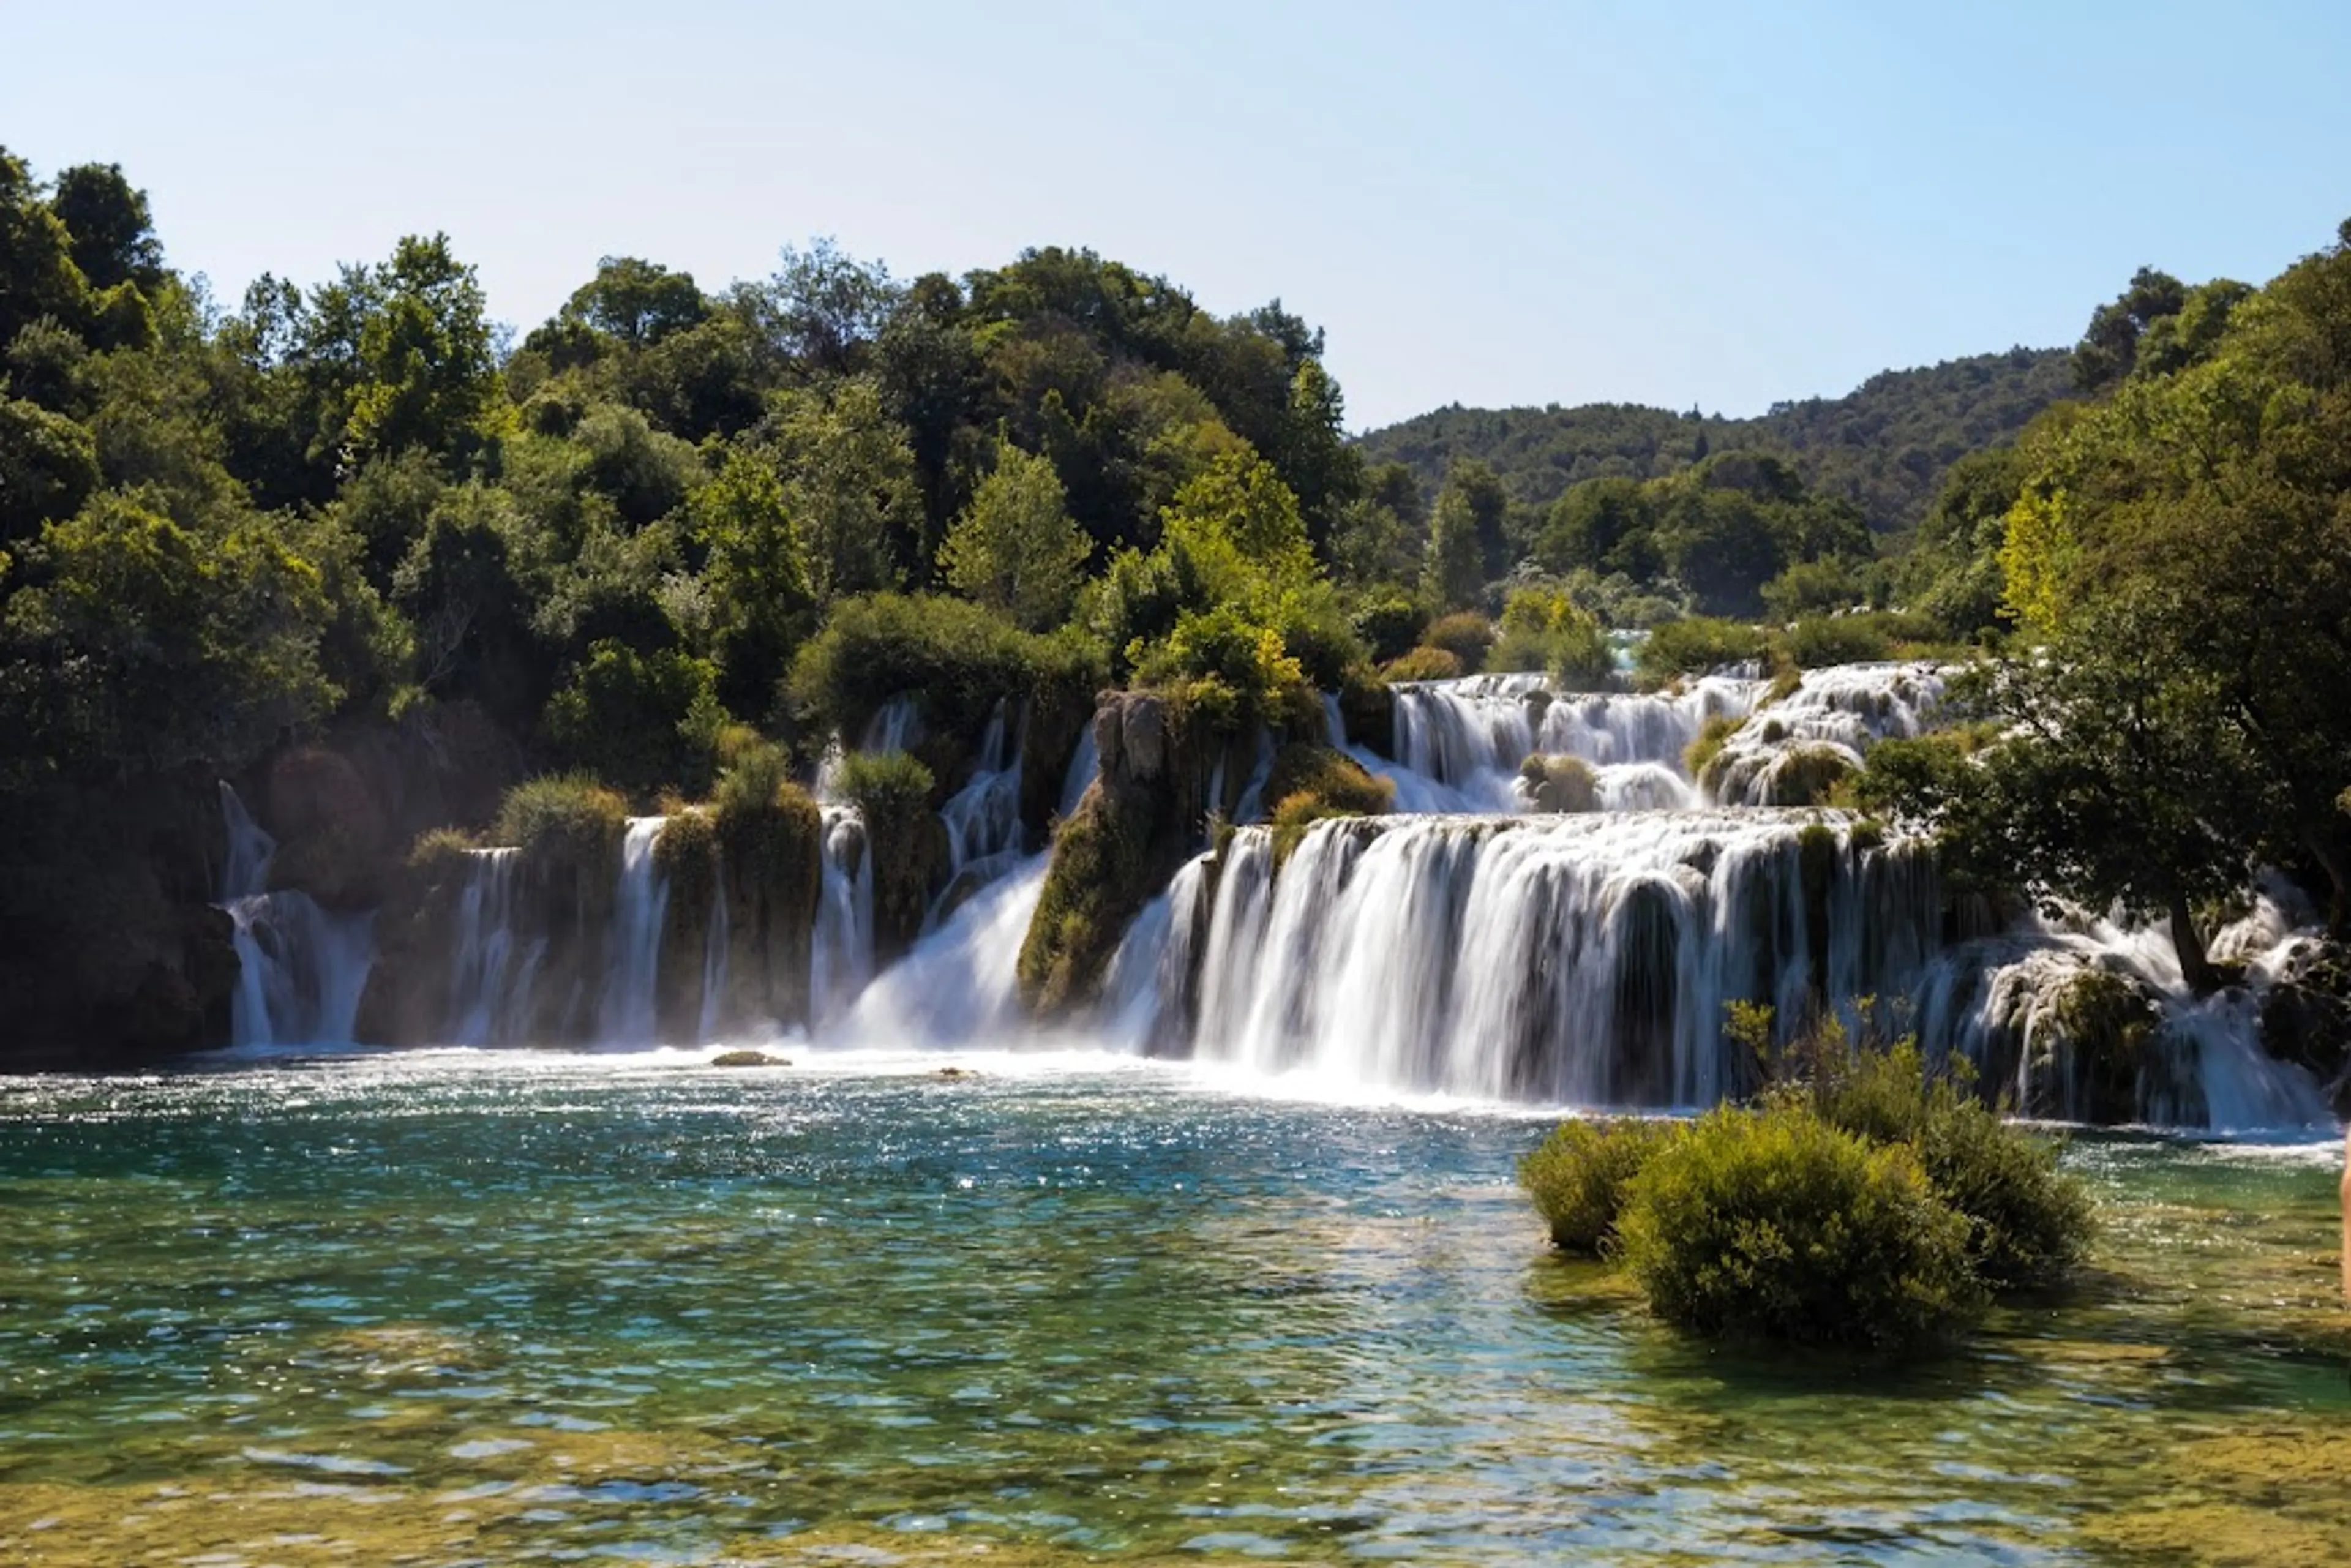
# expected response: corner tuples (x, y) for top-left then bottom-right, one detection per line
(1359, 348), (2074, 534)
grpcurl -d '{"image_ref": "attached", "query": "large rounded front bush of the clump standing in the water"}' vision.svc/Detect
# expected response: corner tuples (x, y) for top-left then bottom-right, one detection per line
(1618, 1103), (1984, 1347)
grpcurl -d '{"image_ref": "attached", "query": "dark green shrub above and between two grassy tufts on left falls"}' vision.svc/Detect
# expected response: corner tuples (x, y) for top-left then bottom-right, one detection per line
(546, 642), (717, 795)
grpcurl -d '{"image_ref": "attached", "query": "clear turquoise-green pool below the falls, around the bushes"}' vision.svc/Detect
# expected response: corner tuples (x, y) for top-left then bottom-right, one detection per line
(0, 1053), (2351, 1568)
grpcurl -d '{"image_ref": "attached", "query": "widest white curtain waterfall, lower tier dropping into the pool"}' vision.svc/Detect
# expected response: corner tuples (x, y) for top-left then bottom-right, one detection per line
(1194, 811), (1940, 1105)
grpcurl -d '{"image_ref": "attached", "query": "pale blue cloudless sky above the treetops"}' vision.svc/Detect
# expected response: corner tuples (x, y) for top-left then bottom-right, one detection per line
(0, 0), (2351, 426)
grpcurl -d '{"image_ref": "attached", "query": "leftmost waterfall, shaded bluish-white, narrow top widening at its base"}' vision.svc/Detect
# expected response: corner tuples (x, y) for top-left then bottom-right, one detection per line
(221, 783), (376, 1046)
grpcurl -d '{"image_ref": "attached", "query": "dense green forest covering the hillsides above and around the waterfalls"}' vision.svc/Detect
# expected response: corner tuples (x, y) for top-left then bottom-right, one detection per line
(0, 153), (2351, 1046)
